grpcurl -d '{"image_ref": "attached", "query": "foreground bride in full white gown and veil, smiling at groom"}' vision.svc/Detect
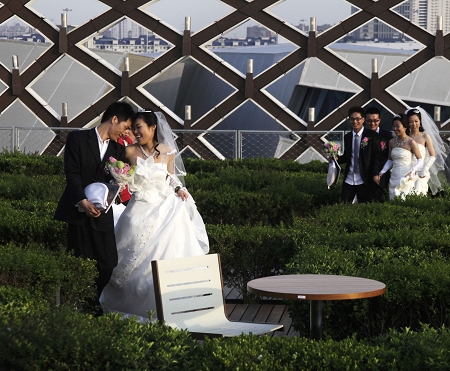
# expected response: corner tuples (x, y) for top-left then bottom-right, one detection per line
(100, 111), (209, 318)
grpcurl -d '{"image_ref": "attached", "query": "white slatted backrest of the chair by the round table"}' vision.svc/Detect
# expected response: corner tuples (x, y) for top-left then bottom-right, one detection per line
(152, 254), (225, 328)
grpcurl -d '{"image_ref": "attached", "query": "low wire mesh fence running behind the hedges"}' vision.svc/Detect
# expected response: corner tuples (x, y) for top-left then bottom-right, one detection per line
(0, 127), (450, 163)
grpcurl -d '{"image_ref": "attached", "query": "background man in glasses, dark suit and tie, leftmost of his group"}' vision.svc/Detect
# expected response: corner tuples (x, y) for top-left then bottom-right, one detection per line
(337, 107), (380, 203)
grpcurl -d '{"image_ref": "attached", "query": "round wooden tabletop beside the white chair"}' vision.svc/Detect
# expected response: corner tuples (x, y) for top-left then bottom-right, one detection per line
(247, 274), (386, 300)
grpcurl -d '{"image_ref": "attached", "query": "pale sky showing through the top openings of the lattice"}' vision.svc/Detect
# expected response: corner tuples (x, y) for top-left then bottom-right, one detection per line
(14, 0), (350, 37)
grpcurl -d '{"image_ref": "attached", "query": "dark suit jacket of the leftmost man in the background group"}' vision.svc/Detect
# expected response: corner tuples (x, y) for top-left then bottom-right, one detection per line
(338, 128), (380, 185)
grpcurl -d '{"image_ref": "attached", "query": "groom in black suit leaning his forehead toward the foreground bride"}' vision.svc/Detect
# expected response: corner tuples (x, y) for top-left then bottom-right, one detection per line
(55, 102), (134, 314)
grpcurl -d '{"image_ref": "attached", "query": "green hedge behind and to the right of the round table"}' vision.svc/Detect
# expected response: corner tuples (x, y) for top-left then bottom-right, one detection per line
(286, 201), (450, 338)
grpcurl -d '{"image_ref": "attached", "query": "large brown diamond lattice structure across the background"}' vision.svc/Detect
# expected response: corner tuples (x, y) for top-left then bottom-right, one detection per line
(0, 0), (450, 158)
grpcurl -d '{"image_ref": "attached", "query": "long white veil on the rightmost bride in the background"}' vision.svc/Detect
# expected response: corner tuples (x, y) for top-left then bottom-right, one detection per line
(405, 106), (450, 194)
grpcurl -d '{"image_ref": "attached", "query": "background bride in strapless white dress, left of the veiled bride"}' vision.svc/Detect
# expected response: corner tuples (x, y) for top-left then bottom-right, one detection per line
(377, 114), (423, 200)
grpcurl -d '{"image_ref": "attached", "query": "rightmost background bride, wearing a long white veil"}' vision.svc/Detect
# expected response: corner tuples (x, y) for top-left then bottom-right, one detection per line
(406, 107), (449, 196)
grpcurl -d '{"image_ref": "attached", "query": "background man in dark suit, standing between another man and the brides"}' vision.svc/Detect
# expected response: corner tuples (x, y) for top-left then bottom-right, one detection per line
(365, 107), (392, 202)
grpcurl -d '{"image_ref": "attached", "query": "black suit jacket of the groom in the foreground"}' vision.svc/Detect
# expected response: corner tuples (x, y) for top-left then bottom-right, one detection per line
(55, 129), (125, 233)
